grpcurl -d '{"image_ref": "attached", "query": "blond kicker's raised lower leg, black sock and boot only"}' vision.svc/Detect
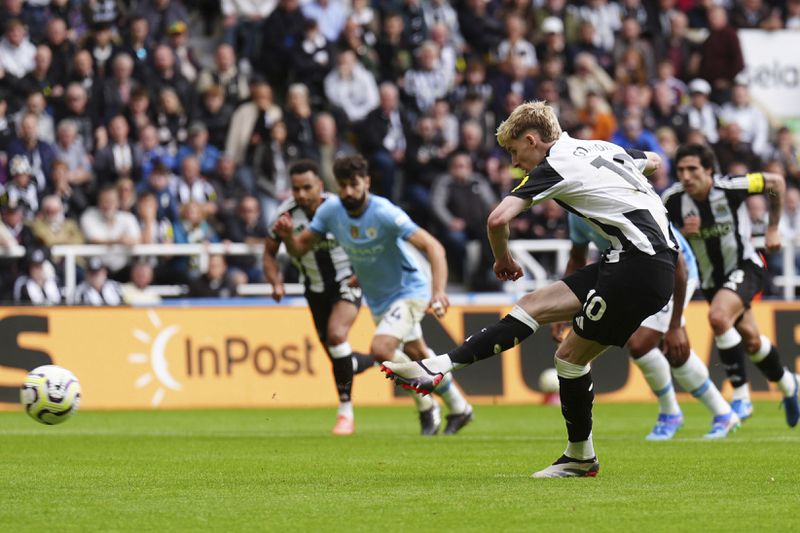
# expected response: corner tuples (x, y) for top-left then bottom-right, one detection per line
(381, 306), (539, 394)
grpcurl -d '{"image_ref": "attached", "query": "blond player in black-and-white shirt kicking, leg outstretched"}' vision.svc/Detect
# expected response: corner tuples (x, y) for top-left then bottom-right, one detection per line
(382, 102), (678, 478)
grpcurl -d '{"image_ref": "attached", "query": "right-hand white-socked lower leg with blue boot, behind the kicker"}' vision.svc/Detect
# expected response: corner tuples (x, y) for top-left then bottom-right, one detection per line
(672, 350), (741, 439)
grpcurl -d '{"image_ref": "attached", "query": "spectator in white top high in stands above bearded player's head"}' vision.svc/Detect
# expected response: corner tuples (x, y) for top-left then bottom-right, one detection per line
(325, 51), (379, 124)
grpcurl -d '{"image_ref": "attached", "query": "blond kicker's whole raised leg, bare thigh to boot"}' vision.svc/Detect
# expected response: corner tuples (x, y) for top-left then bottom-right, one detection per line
(381, 281), (581, 394)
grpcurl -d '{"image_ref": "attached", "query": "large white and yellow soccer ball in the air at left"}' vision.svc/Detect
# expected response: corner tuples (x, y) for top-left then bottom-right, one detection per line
(19, 365), (81, 425)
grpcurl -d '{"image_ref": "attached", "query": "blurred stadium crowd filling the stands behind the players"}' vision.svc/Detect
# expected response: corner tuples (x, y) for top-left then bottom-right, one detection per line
(0, 0), (800, 305)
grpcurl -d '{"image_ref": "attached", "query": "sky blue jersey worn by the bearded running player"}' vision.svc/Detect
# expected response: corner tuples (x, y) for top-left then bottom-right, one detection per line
(309, 195), (431, 315)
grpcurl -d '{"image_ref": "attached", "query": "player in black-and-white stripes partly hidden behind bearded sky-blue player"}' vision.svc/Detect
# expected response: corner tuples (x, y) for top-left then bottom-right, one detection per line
(264, 160), (374, 435)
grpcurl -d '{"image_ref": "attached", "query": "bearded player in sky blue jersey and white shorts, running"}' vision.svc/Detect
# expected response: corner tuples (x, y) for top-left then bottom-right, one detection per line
(274, 155), (473, 435)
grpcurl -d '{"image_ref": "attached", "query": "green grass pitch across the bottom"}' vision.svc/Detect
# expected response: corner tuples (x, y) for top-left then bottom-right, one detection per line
(0, 401), (800, 533)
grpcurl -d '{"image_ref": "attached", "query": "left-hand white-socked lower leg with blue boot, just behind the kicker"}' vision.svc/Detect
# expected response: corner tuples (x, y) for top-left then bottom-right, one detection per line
(633, 348), (683, 440)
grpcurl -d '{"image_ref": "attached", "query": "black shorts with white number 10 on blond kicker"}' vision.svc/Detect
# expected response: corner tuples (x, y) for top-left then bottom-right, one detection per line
(563, 250), (677, 346)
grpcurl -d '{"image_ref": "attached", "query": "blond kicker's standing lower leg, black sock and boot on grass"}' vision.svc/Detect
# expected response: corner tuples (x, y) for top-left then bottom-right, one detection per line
(533, 357), (600, 478)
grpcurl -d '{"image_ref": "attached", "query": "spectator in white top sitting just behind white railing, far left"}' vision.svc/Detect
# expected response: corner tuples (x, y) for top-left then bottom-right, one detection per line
(81, 184), (142, 274)
